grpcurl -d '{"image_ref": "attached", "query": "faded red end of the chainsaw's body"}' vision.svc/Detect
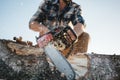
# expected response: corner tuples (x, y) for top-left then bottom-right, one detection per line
(37, 33), (53, 48)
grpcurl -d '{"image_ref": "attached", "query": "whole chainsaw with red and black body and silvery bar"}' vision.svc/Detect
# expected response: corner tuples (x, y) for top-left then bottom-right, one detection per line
(37, 26), (77, 80)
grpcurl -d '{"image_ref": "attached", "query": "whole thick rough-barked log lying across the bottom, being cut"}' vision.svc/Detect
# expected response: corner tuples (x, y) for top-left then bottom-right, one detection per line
(0, 39), (120, 80)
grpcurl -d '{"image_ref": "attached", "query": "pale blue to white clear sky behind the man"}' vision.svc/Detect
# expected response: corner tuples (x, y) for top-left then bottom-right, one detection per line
(0, 0), (120, 55)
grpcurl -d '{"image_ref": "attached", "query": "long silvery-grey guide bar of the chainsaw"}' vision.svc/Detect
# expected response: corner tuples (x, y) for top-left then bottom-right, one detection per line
(44, 43), (75, 80)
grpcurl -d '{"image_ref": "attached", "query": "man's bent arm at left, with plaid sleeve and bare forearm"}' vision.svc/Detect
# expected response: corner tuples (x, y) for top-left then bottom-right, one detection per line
(29, 3), (49, 35)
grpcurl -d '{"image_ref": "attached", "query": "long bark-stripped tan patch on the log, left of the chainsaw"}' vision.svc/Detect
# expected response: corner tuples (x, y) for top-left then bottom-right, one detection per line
(7, 42), (44, 56)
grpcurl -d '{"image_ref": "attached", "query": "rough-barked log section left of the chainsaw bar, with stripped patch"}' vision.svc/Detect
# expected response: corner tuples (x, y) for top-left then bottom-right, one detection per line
(0, 40), (66, 80)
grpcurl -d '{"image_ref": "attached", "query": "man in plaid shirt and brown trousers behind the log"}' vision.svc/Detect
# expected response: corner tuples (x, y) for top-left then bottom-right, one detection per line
(29, 0), (89, 54)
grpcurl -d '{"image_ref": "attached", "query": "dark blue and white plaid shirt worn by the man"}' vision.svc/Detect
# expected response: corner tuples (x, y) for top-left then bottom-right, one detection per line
(30, 2), (84, 28)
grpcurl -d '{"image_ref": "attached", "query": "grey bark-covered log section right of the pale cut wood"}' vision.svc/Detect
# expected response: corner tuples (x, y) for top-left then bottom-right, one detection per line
(85, 54), (120, 80)
